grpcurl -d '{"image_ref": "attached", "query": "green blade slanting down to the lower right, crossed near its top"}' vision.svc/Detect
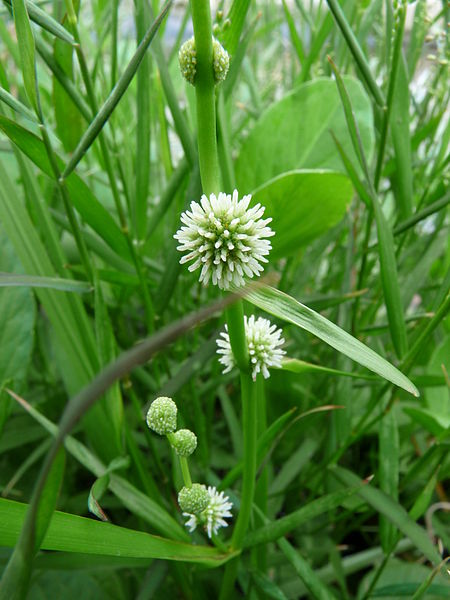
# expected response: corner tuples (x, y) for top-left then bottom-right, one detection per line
(330, 466), (441, 565)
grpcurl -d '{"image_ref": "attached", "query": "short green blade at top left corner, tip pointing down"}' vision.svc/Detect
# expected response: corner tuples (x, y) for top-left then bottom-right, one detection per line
(12, 0), (39, 112)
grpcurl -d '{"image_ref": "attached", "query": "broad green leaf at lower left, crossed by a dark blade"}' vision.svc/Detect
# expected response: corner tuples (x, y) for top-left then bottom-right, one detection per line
(0, 498), (235, 567)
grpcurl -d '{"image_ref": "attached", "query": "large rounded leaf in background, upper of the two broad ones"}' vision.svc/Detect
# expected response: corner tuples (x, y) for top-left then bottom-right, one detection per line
(236, 78), (374, 192)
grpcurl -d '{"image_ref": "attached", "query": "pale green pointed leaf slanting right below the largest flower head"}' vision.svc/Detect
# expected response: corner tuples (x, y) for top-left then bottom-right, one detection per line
(246, 287), (419, 396)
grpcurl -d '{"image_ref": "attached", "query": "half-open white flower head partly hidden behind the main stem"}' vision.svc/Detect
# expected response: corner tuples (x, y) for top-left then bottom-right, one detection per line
(217, 315), (286, 380)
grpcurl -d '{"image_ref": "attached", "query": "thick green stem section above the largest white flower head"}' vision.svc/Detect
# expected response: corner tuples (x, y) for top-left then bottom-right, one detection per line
(191, 0), (220, 196)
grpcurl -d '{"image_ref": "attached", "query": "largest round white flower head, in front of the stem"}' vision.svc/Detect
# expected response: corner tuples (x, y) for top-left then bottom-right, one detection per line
(174, 190), (274, 290)
